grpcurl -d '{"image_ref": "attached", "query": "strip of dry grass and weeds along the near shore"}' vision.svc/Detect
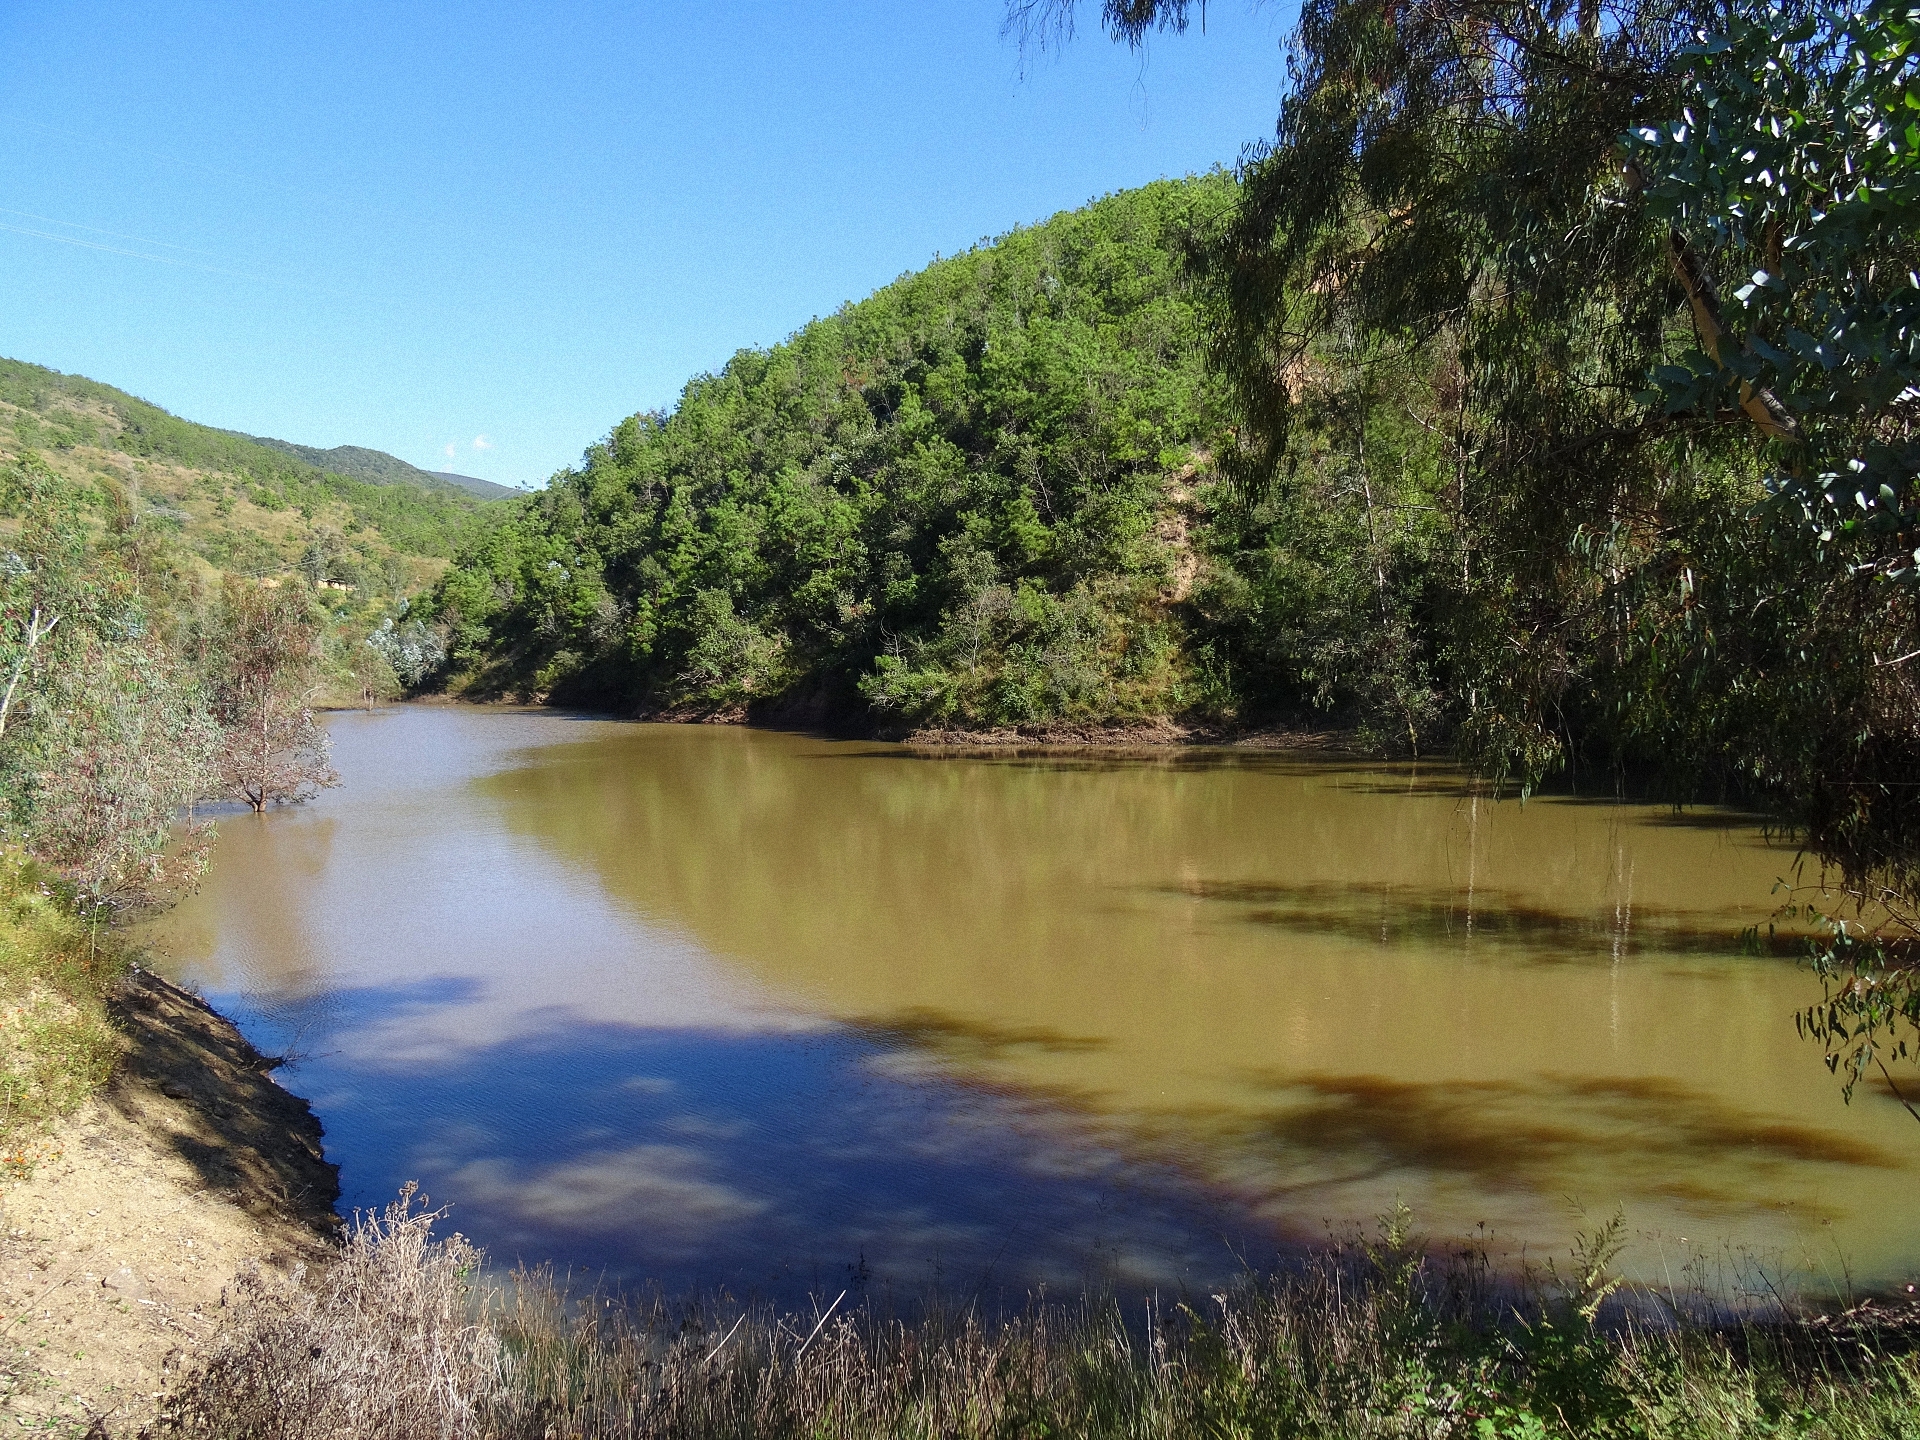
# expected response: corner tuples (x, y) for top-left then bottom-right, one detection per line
(157, 1198), (1920, 1440)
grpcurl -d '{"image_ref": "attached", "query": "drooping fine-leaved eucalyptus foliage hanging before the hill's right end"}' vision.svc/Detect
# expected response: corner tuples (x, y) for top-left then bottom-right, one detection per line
(1010, 0), (1728, 787)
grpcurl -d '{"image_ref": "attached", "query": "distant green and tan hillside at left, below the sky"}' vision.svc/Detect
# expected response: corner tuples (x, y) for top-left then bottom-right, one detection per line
(0, 359), (482, 593)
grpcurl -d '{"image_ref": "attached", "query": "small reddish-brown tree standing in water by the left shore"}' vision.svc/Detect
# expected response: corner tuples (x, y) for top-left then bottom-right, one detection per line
(207, 580), (340, 810)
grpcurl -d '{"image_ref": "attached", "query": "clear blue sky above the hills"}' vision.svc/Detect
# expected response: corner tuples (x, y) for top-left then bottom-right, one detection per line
(0, 0), (1292, 484)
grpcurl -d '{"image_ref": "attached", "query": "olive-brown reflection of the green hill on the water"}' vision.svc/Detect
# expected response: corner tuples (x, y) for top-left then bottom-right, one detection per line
(476, 726), (1914, 1269)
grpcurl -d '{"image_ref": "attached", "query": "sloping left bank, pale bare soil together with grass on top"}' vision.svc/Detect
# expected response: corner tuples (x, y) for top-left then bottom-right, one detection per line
(0, 917), (338, 1436)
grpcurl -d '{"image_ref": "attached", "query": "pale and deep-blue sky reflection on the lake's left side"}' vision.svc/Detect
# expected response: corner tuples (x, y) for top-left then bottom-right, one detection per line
(150, 708), (1290, 1300)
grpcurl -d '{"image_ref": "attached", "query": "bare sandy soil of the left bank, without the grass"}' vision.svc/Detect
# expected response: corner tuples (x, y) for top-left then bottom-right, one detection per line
(0, 970), (340, 1434)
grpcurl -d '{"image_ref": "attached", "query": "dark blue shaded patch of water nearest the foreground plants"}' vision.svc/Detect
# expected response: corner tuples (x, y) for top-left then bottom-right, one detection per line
(295, 1025), (1246, 1296)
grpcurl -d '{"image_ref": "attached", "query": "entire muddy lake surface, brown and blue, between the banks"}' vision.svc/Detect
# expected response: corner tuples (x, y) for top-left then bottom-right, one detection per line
(154, 707), (1920, 1296)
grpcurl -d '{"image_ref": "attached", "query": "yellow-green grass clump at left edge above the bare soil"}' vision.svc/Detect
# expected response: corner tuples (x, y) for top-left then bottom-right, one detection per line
(0, 849), (127, 1171)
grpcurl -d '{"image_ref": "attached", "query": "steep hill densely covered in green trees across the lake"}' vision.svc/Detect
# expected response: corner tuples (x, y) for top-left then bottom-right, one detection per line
(434, 173), (1520, 747)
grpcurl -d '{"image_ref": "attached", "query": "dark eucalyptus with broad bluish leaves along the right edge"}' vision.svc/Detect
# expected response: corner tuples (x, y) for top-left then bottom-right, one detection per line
(1628, 0), (1920, 1117)
